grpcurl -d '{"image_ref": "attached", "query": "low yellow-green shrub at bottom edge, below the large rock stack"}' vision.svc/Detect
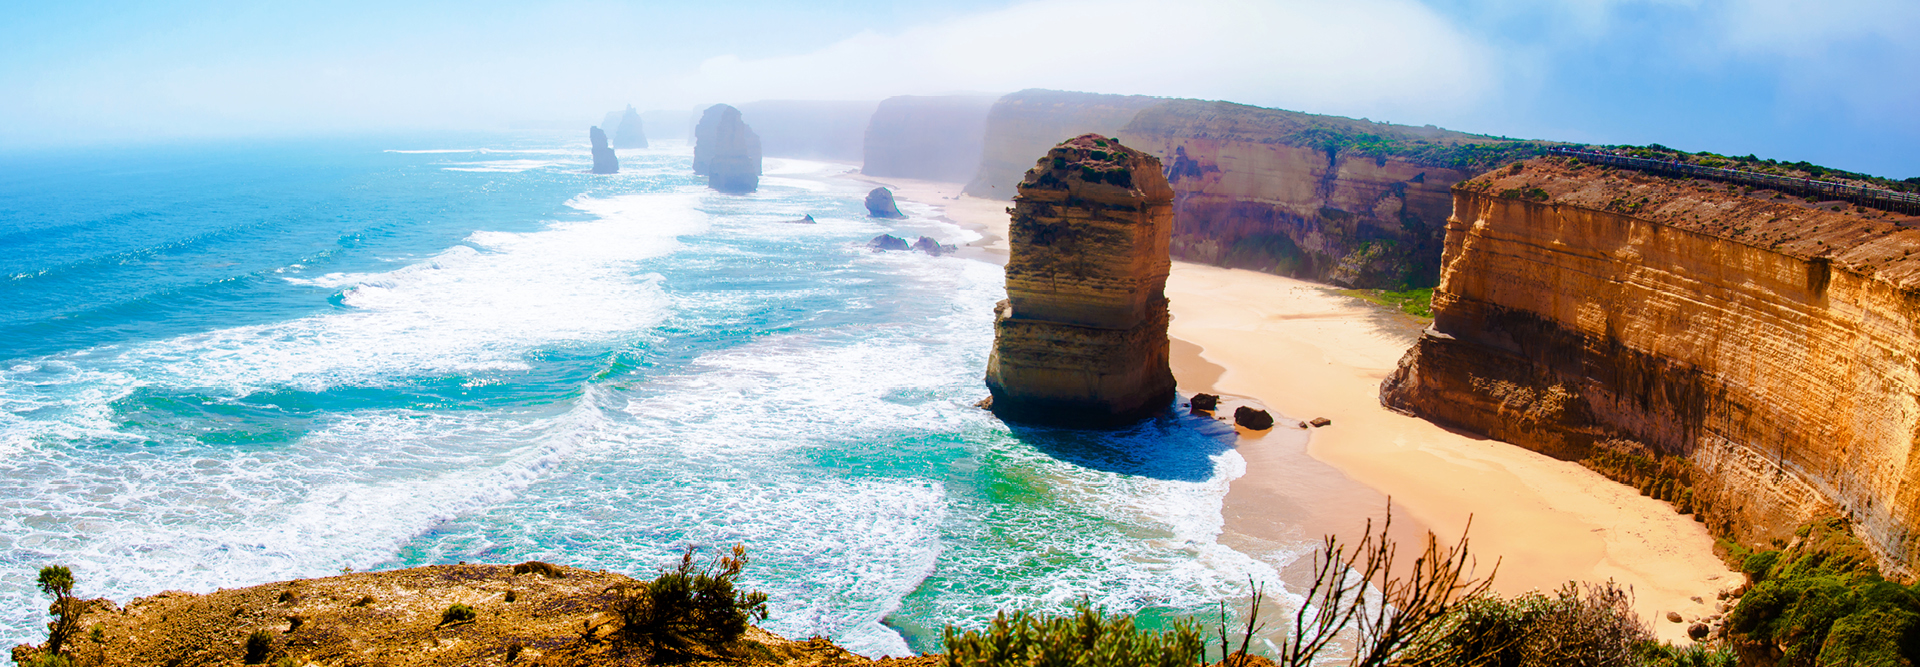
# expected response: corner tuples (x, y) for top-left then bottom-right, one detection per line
(941, 602), (1204, 667)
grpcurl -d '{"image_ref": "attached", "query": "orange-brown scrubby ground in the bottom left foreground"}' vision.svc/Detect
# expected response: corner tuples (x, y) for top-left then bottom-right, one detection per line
(15, 563), (927, 667)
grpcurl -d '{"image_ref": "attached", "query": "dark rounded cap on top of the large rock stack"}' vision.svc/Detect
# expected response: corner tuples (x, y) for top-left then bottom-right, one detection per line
(1014, 133), (1173, 204)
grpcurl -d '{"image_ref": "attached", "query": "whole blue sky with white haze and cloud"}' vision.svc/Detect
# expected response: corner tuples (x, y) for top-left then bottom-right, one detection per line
(11, 0), (1920, 179)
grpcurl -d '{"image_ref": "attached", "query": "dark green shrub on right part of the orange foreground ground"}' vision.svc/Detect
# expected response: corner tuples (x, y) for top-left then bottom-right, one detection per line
(614, 544), (766, 657)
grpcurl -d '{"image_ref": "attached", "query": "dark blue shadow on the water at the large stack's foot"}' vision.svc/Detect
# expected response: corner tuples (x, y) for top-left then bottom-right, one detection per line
(1006, 399), (1235, 482)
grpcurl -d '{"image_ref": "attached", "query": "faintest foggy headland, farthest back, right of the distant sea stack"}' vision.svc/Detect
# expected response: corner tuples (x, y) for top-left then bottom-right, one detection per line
(739, 100), (879, 163)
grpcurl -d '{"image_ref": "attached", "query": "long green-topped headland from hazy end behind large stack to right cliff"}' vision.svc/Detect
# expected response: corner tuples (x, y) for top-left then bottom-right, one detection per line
(966, 90), (1540, 288)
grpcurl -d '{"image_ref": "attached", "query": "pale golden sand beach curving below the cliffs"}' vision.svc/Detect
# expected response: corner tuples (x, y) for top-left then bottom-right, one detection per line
(871, 175), (1745, 644)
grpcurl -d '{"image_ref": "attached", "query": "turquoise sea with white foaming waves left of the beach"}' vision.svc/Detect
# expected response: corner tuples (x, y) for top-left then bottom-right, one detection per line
(0, 133), (1275, 655)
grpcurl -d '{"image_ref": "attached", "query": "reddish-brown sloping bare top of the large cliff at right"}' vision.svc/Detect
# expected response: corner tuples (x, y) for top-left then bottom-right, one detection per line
(1455, 158), (1920, 288)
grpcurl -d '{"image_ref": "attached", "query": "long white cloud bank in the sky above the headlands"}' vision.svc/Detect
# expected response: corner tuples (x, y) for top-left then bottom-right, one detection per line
(676, 0), (1496, 119)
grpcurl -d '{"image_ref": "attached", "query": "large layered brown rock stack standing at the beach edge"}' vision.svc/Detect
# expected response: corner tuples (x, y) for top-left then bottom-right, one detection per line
(987, 135), (1173, 427)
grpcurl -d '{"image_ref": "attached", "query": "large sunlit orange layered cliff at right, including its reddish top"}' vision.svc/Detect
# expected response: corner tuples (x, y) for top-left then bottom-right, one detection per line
(1380, 158), (1920, 573)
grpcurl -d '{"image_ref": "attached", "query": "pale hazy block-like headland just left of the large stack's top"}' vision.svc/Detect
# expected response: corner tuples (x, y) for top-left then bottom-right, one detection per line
(860, 94), (998, 183)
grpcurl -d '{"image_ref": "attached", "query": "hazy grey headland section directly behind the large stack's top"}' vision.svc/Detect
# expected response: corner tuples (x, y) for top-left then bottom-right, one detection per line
(964, 88), (1164, 200)
